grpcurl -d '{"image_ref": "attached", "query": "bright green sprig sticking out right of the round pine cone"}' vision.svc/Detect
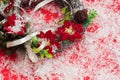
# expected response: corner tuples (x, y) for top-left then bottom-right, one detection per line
(83, 9), (97, 27)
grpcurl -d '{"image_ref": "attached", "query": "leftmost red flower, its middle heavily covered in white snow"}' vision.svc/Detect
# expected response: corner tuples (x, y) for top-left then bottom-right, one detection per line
(3, 14), (26, 35)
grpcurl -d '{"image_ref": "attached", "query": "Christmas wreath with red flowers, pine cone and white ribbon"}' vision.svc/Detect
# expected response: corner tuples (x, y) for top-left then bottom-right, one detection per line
(0, 0), (97, 62)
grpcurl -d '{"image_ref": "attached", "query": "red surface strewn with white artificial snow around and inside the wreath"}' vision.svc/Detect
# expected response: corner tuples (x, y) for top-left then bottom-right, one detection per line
(0, 0), (120, 80)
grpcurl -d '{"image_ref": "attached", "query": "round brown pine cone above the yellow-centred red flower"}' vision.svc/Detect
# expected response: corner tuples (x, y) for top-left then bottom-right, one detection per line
(74, 9), (88, 24)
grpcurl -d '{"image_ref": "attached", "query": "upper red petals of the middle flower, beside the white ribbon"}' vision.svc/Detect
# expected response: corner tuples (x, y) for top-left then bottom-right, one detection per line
(37, 30), (60, 48)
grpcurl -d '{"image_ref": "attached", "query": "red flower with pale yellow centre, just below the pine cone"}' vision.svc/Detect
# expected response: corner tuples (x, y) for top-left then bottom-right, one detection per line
(56, 21), (83, 41)
